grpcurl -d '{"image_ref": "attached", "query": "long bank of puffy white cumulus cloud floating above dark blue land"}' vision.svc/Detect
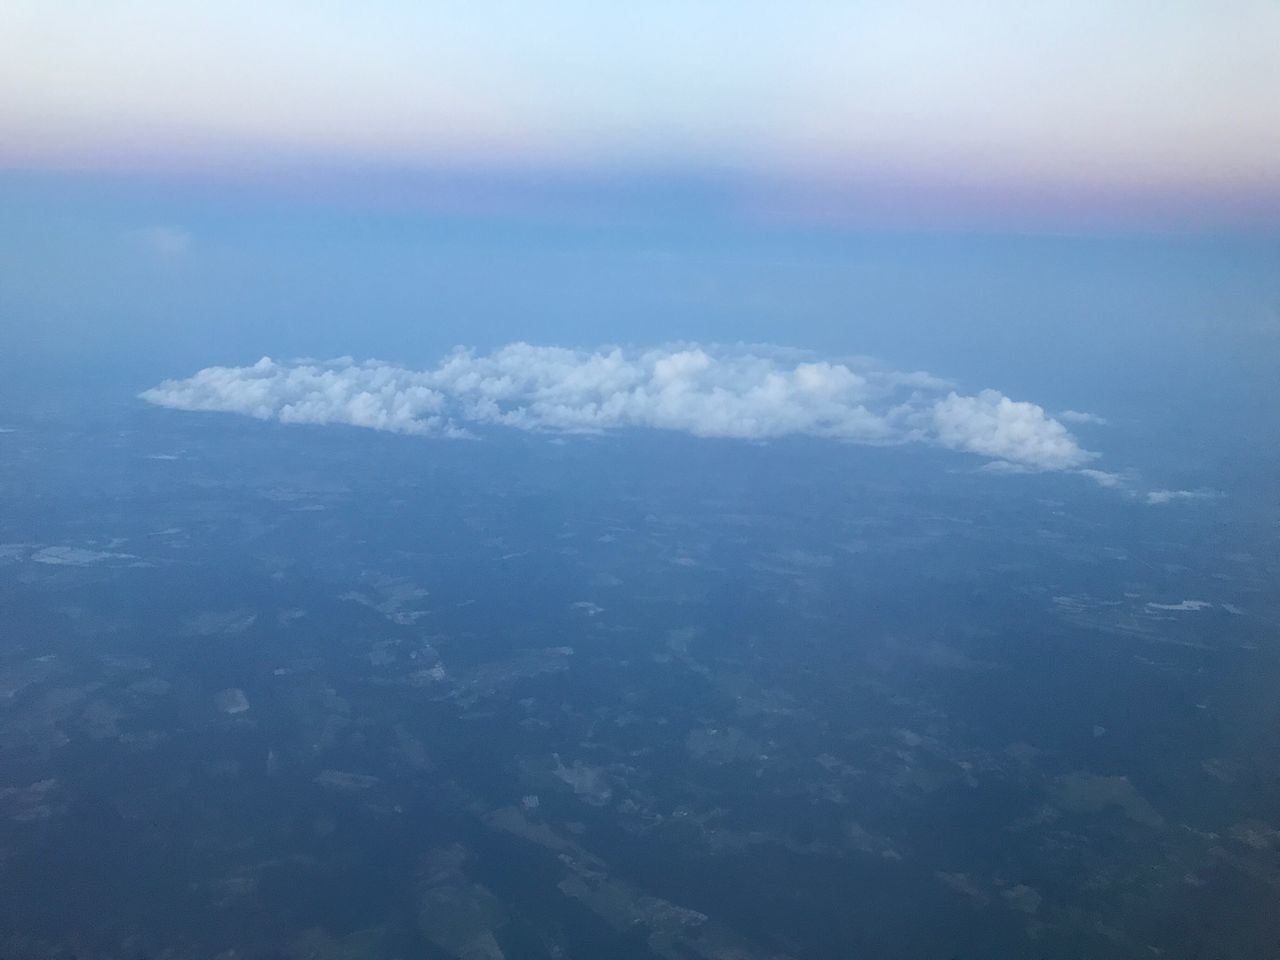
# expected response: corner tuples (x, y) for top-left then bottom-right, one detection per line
(141, 343), (1098, 472)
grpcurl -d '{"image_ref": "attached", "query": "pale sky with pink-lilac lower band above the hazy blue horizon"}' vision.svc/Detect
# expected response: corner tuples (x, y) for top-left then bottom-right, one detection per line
(0, 0), (1280, 228)
